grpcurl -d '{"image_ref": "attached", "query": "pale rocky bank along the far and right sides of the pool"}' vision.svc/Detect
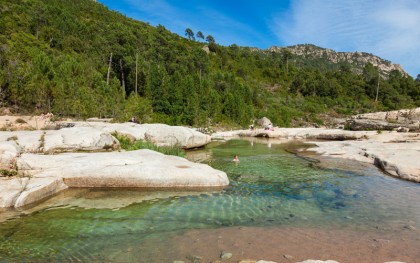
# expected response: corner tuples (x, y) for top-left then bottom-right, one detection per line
(212, 127), (420, 182)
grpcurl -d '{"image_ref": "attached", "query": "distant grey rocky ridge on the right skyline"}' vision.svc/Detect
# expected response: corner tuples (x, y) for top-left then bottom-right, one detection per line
(268, 44), (408, 76)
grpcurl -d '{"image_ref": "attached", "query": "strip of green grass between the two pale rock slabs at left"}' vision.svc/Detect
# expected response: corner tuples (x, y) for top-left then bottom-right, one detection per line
(112, 133), (185, 157)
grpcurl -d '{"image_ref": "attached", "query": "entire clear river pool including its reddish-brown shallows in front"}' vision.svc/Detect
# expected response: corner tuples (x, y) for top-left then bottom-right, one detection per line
(0, 130), (420, 263)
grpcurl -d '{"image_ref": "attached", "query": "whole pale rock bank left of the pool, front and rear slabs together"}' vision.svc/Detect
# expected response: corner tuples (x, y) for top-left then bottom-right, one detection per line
(0, 122), (229, 208)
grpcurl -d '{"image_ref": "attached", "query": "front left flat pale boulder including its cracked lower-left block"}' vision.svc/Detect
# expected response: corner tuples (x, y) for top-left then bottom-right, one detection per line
(0, 150), (229, 207)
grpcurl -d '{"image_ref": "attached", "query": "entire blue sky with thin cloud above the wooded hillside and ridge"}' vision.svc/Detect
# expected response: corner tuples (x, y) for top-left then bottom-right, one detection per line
(98, 0), (420, 77)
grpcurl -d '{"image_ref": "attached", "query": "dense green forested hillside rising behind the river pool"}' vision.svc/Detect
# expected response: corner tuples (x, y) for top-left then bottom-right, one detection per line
(0, 0), (420, 126)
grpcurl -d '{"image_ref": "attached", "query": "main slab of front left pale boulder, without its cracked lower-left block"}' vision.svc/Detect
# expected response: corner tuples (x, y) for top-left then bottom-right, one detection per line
(17, 150), (229, 187)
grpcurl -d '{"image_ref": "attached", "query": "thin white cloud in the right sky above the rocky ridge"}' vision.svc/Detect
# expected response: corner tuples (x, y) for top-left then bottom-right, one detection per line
(271, 0), (420, 77)
